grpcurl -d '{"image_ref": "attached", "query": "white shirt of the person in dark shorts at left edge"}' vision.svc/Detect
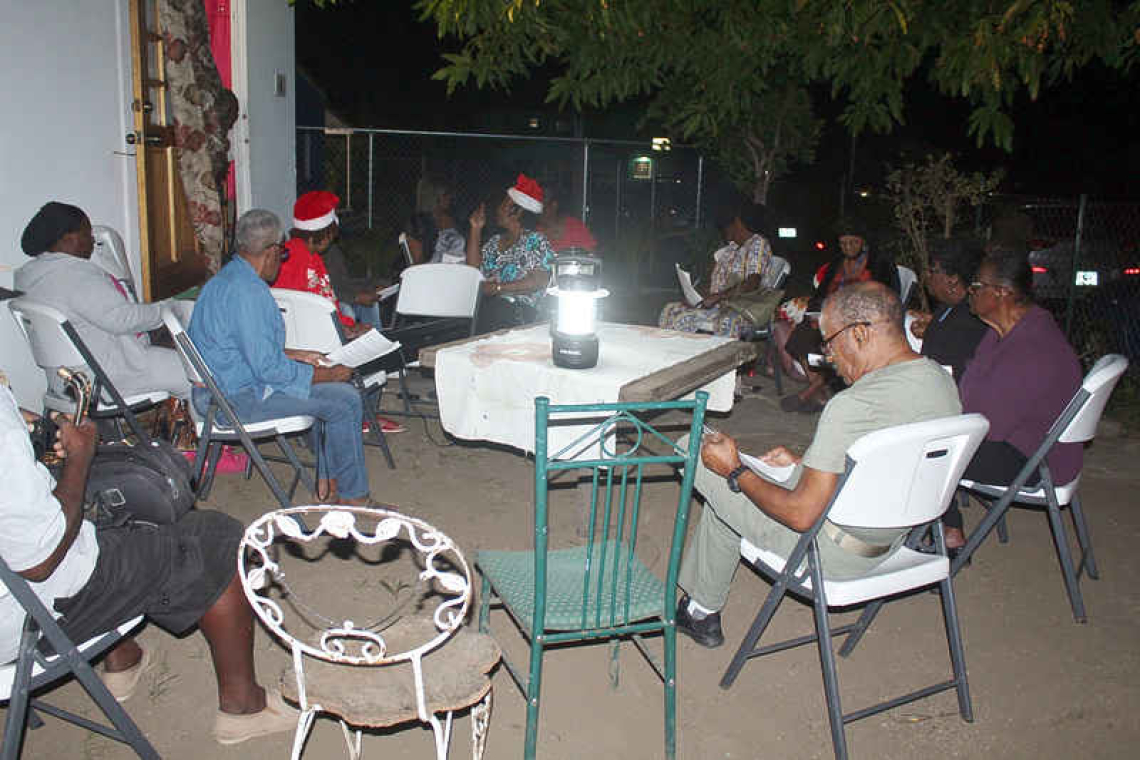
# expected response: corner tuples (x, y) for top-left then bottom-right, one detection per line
(0, 386), (99, 663)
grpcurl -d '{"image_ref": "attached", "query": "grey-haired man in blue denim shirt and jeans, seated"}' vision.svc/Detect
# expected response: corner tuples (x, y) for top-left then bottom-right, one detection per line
(187, 209), (369, 505)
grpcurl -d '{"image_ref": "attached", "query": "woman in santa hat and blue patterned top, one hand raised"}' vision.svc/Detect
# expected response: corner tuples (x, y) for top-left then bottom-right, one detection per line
(467, 174), (554, 333)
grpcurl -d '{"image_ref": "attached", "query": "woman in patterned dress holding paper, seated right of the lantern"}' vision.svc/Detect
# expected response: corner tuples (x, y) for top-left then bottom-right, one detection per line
(658, 203), (772, 337)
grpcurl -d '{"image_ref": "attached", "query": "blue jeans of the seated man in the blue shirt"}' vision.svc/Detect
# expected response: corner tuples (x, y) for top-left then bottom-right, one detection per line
(194, 383), (368, 499)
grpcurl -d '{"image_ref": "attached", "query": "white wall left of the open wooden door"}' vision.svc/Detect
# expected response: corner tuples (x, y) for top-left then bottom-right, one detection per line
(0, 0), (135, 409)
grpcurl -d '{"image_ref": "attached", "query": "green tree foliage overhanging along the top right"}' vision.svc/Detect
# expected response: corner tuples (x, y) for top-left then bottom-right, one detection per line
(416, 0), (1140, 149)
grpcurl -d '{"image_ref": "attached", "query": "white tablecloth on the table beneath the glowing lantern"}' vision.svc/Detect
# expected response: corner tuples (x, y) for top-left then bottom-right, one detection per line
(435, 322), (735, 453)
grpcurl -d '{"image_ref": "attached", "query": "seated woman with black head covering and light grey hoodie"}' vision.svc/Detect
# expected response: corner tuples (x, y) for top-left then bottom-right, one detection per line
(15, 201), (190, 399)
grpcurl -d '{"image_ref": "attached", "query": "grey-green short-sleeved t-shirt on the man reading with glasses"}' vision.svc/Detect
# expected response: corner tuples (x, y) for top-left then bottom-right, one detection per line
(803, 358), (962, 474)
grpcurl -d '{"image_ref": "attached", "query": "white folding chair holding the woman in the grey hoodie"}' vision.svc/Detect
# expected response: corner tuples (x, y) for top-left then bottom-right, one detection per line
(8, 296), (170, 443)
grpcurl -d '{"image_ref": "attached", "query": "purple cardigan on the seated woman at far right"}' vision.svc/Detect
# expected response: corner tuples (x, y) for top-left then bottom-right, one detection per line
(959, 307), (1084, 485)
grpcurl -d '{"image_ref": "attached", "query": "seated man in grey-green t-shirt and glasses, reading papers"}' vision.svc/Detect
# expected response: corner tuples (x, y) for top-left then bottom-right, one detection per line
(677, 283), (962, 647)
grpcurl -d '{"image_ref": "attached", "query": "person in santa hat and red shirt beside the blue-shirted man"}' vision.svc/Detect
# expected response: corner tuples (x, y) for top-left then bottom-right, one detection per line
(272, 190), (406, 433)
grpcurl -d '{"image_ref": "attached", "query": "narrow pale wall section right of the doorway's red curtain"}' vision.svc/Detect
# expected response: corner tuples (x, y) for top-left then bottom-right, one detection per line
(230, 0), (296, 229)
